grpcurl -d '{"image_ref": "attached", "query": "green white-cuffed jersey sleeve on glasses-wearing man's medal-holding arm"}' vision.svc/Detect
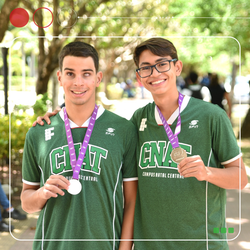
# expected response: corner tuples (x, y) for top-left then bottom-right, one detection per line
(212, 110), (242, 165)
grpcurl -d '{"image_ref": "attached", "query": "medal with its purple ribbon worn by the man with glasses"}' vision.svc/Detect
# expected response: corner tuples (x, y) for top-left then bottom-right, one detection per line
(157, 93), (187, 164)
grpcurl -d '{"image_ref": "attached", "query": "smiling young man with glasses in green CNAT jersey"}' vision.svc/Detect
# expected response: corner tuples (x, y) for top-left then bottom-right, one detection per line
(131, 38), (247, 250)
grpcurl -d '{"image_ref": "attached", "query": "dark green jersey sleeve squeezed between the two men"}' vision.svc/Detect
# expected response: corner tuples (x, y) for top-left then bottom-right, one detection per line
(122, 122), (138, 181)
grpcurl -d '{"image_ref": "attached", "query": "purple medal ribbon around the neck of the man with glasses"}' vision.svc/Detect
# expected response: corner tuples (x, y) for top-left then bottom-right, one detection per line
(156, 93), (184, 148)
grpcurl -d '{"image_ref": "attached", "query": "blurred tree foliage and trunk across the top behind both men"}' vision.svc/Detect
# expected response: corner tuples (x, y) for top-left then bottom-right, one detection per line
(0, 0), (250, 94)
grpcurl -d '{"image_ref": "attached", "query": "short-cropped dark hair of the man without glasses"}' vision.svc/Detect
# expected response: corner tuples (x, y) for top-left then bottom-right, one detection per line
(59, 41), (99, 72)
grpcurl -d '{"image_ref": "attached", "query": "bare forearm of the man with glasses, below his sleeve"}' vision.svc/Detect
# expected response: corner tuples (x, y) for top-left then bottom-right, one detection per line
(206, 164), (248, 189)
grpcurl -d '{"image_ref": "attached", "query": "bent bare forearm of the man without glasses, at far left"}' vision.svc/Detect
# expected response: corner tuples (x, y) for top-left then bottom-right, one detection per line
(21, 187), (47, 213)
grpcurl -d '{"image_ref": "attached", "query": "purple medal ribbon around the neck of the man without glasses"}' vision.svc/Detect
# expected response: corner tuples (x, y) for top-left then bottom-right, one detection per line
(64, 105), (98, 180)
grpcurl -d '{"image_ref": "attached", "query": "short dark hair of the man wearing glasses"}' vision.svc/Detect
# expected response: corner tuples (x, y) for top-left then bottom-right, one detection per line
(133, 37), (178, 67)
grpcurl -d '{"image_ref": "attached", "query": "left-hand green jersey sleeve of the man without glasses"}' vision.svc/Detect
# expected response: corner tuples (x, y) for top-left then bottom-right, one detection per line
(22, 128), (41, 185)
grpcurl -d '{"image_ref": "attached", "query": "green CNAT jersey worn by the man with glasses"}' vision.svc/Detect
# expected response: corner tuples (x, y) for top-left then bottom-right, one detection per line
(131, 96), (241, 250)
